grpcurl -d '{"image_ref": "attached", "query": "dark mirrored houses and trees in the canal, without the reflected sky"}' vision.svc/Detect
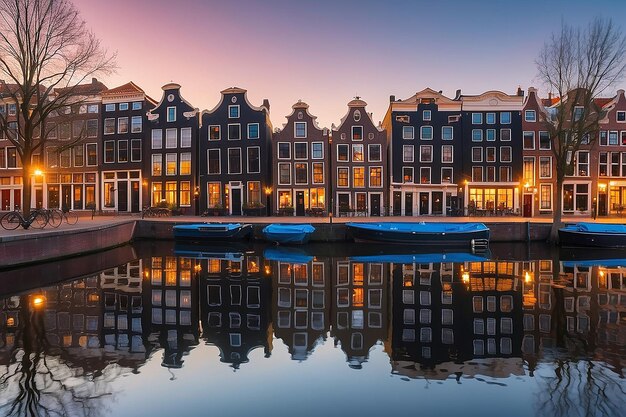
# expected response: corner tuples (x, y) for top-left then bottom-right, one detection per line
(0, 240), (626, 416)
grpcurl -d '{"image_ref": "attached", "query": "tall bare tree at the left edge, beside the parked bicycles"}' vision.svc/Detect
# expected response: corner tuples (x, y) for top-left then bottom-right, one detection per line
(0, 0), (115, 219)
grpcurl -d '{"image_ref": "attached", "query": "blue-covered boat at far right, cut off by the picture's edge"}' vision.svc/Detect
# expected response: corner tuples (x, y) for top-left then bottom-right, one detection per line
(559, 223), (626, 248)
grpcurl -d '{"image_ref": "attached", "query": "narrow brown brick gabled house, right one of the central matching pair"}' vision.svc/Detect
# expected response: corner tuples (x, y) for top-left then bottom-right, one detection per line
(328, 97), (388, 216)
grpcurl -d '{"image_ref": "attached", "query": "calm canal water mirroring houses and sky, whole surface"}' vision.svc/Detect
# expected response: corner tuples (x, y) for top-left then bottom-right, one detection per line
(0, 242), (626, 417)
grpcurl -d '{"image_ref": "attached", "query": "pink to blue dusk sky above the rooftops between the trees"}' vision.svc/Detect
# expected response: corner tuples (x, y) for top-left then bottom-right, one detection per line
(74, 0), (626, 127)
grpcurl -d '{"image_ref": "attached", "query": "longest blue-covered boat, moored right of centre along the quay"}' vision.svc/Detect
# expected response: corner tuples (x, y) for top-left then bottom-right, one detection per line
(346, 222), (489, 247)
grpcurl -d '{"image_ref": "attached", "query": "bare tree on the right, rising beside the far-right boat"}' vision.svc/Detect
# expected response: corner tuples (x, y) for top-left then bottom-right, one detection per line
(536, 18), (626, 242)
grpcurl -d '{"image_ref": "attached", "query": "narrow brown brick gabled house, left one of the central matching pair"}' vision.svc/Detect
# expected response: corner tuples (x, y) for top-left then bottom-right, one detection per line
(272, 100), (329, 216)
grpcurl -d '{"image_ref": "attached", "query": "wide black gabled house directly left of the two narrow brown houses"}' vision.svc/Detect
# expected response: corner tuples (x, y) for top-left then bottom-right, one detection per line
(199, 87), (272, 215)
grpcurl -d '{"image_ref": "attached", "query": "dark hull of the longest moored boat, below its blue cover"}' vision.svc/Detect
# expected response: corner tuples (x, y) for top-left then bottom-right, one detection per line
(346, 223), (489, 247)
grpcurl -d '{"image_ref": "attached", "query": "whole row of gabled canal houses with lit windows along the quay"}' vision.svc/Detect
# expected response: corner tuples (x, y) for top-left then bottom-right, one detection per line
(0, 79), (626, 217)
